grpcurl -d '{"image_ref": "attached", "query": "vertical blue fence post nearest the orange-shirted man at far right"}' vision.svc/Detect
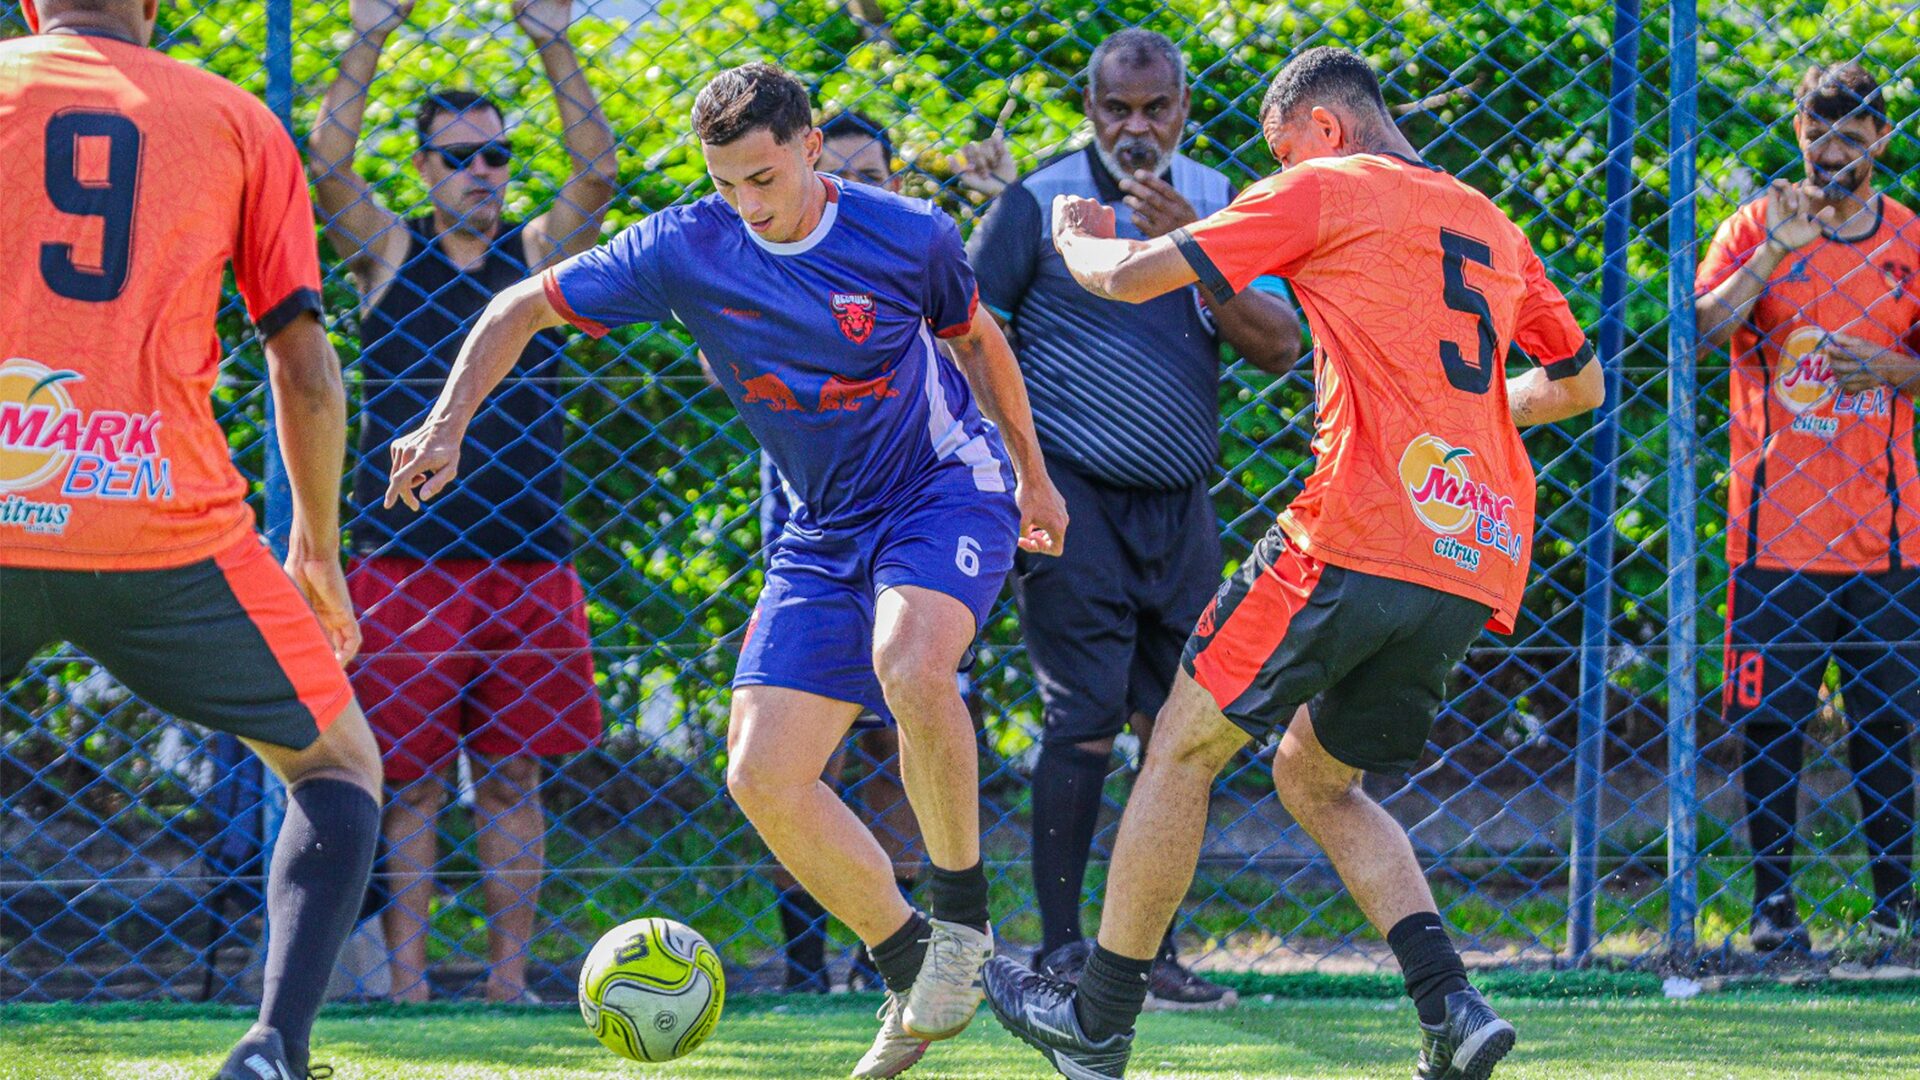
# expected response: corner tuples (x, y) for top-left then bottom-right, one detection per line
(1667, 0), (1699, 957)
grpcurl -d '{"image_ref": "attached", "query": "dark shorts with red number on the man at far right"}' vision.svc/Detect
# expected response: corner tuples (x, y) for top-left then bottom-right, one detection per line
(1722, 567), (1920, 728)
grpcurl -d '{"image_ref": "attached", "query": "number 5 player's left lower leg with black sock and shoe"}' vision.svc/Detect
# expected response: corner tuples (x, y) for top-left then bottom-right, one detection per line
(987, 673), (1246, 1080)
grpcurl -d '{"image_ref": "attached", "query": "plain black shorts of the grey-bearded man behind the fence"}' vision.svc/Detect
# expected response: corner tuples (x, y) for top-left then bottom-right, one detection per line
(1014, 459), (1223, 746)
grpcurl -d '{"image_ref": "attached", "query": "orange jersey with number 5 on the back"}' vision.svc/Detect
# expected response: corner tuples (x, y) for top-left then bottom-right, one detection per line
(1175, 154), (1592, 632)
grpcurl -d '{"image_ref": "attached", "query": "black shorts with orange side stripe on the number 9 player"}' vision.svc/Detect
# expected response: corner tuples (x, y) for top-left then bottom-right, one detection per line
(0, 536), (353, 749)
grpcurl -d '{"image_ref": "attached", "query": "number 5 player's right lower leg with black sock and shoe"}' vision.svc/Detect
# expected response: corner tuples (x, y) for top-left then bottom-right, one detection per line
(1273, 707), (1515, 1080)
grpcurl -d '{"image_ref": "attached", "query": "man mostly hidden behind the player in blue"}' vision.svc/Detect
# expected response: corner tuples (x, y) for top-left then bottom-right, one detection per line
(764, 111), (936, 994)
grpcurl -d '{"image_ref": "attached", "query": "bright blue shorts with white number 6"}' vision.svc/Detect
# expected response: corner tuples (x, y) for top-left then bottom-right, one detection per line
(733, 490), (1020, 721)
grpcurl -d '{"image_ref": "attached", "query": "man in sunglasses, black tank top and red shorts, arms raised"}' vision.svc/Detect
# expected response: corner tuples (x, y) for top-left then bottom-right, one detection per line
(309, 0), (614, 1001)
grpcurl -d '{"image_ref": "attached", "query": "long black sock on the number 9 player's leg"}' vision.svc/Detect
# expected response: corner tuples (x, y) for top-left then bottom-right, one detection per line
(259, 780), (380, 1076)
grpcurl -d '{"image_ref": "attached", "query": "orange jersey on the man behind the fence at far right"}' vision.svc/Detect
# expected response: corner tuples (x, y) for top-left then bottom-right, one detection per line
(1697, 196), (1920, 573)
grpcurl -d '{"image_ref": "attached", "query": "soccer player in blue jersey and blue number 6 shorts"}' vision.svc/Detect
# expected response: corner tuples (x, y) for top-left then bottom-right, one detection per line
(386, 63), (1068, 1076)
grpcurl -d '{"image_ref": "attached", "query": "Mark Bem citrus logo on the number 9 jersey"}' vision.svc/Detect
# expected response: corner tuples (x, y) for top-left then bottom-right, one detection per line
(0, 357), (173, 532)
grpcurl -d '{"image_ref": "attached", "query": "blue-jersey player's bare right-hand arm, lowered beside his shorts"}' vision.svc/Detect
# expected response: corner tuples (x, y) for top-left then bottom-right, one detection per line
(947, 306), (1068, 555)
